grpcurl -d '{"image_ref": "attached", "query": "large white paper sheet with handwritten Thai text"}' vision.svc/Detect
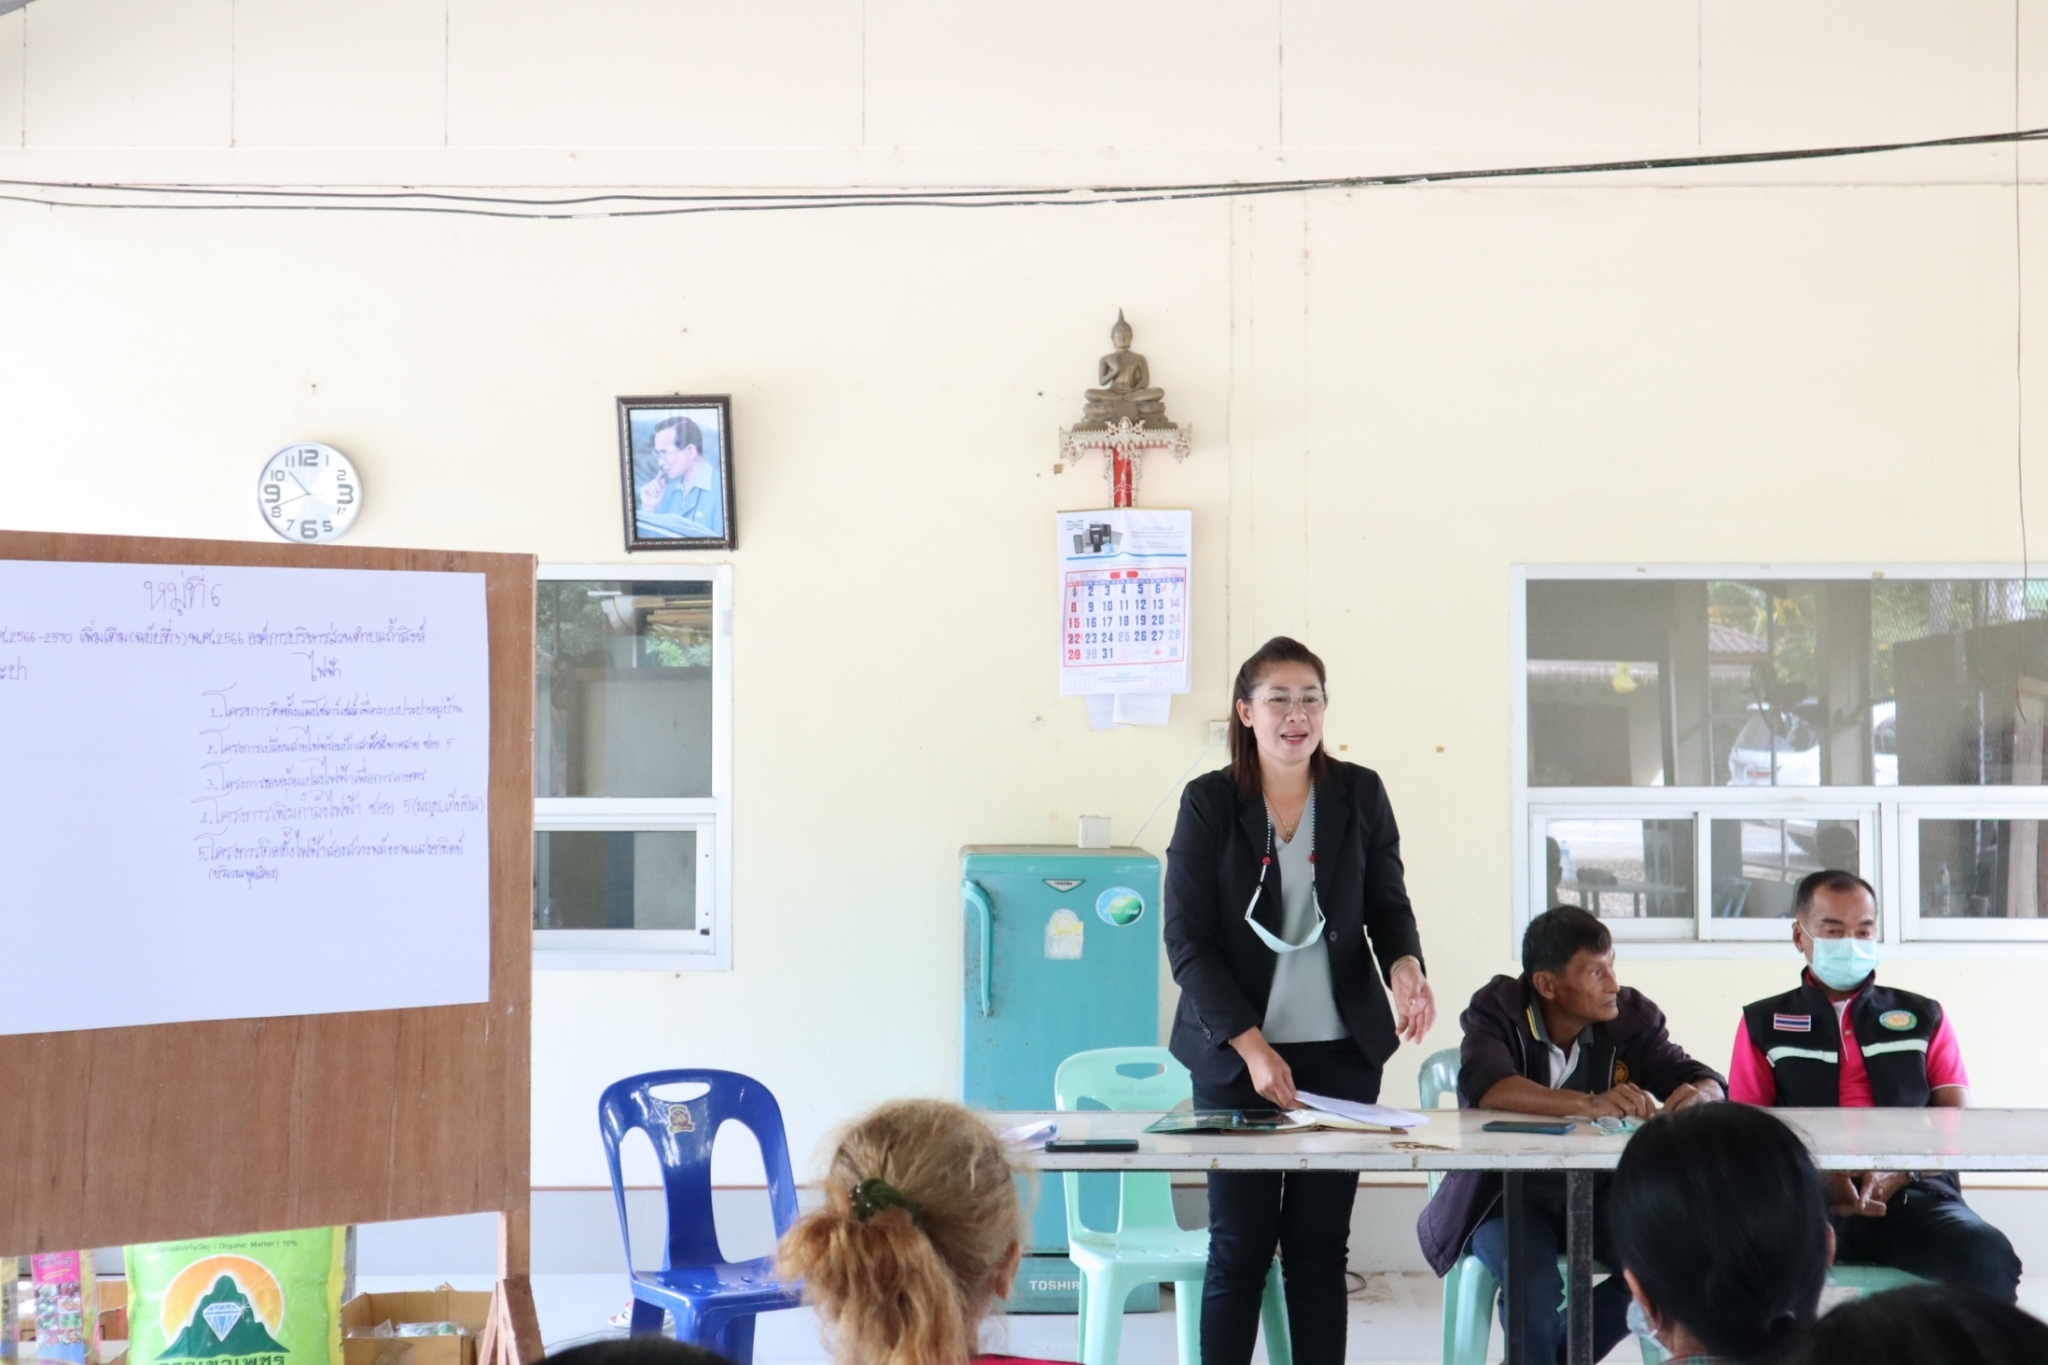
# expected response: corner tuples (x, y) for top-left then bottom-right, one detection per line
(0, 561), (489, 1036)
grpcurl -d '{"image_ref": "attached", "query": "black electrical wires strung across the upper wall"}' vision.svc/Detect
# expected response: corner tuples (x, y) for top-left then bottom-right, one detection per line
(0, 129), (2048, 219)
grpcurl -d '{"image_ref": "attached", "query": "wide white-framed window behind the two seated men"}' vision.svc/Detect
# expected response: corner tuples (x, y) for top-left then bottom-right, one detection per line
(1513, 565), (2048, 943)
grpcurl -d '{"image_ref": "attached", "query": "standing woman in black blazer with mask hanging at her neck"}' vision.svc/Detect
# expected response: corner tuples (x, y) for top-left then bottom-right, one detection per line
(1165, 636), (1436, 1365)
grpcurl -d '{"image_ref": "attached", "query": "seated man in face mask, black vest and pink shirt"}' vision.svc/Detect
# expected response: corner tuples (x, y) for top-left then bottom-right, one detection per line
(1729, 872), (2019, 1304)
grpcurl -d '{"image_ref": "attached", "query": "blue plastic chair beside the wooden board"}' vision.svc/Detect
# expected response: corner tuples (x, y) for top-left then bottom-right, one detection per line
(598, 1070), (799, 1365)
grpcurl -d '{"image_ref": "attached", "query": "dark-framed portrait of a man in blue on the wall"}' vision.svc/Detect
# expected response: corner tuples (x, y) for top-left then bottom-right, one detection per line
(618, 393), (733, 551)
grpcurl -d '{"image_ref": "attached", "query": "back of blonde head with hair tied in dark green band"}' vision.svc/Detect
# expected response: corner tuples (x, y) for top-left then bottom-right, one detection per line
(778, 1099), (1020, 1365)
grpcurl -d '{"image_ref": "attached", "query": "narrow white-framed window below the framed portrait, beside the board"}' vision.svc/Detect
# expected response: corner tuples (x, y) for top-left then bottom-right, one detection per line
(532, 565), (733, 970)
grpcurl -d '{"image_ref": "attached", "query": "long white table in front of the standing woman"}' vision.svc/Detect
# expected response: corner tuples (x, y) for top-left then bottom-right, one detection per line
(985, 1109), (2048, 1365)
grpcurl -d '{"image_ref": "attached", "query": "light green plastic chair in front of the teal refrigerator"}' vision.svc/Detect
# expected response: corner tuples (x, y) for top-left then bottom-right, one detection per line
(1053, 1048), (1294, 1365)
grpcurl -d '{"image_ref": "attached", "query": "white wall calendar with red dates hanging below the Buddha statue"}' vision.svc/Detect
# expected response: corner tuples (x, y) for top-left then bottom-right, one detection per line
(1059, 508), (1194, 696)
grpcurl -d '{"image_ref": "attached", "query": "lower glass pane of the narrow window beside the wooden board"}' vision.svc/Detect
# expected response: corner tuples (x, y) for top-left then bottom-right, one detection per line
(532, 829), (709, 933)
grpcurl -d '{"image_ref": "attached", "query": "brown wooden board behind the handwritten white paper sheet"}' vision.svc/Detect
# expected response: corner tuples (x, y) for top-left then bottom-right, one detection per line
(0, 532), (541, 1365)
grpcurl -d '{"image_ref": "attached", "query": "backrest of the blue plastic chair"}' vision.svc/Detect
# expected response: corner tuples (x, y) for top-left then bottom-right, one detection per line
(598, 1068), (797, 1269)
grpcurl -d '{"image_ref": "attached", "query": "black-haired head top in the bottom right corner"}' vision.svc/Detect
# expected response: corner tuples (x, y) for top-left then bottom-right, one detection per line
(1798, 1285), (2048, 1365)
